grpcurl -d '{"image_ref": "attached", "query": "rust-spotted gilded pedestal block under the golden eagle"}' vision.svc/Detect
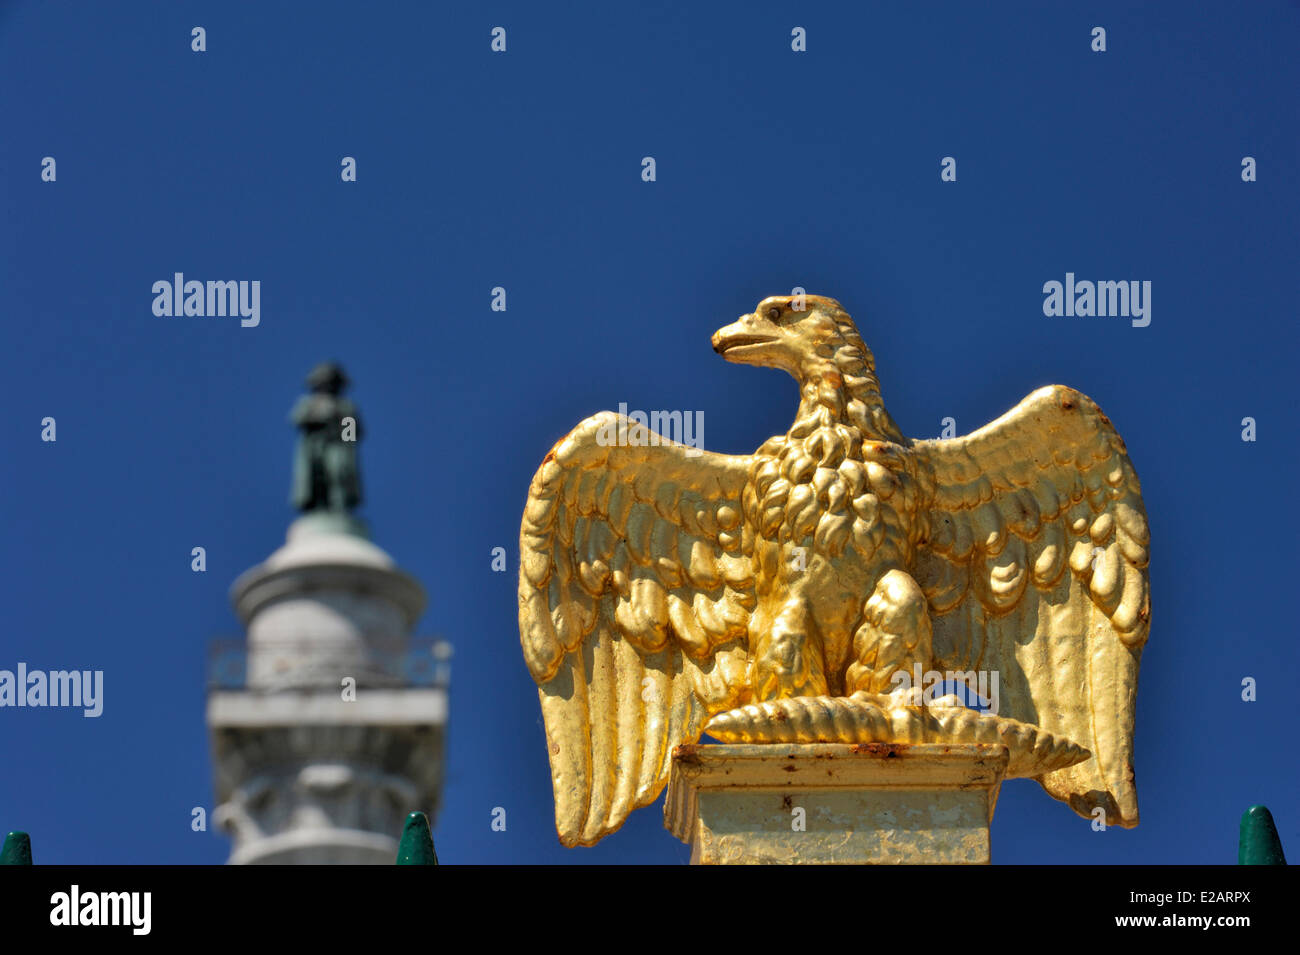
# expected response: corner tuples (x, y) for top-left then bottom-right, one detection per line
(664, 743), (1009, 865)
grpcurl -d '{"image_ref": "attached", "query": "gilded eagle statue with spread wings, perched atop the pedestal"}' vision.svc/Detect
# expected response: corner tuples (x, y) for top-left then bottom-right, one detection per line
(519, 295), (1151, 846)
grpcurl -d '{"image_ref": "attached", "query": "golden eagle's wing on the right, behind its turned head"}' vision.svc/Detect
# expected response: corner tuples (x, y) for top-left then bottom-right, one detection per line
(913, 386), (1151, 826)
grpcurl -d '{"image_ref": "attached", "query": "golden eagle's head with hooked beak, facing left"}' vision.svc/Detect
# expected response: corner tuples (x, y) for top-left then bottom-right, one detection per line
(712, 295), (862, 382)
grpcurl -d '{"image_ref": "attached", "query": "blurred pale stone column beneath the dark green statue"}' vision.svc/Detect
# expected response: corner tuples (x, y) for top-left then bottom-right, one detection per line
(208, 512), (447, 865)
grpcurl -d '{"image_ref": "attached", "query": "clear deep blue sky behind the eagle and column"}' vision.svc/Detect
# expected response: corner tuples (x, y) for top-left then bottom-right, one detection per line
(0, 1), (1300, 863)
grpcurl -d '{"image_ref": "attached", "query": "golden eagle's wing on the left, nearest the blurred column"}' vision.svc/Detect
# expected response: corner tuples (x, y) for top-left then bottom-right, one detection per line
(519, 412), (754, 846)
